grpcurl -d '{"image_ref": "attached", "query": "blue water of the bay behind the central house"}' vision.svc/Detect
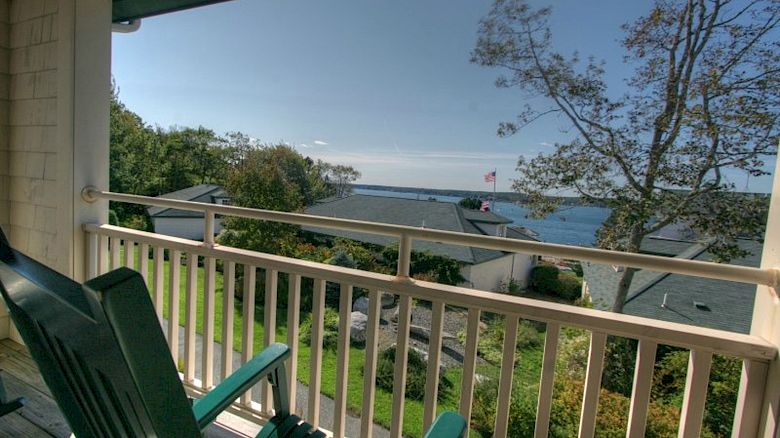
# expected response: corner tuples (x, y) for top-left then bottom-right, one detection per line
(355, 189), (609, 246)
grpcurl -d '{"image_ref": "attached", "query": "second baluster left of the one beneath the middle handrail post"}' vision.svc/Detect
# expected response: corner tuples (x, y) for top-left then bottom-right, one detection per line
(333, 283), (352, 438)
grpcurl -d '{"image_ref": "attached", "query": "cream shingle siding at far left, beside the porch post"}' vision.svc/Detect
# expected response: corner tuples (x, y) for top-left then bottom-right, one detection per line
(0, 0), (59, 270)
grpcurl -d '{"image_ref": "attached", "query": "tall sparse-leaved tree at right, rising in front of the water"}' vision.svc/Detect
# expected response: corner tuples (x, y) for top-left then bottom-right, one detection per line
(472, 0), (780, 312)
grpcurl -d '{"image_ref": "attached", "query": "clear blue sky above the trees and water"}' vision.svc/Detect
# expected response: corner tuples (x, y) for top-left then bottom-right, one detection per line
(113, 0), (770, 191)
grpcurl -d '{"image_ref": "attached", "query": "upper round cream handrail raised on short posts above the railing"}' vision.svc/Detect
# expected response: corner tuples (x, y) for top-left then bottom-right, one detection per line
(82, 186), (780, 287)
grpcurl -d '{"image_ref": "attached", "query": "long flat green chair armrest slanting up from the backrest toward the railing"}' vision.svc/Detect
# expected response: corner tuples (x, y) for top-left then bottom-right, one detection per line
(192, 344), (290, 430)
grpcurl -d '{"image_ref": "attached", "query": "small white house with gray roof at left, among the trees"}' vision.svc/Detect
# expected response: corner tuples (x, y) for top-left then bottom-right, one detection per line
(147, 184), (230, 240)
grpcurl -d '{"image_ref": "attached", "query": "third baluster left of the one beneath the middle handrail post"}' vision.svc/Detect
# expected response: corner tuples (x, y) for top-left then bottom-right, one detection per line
(306, 278), (326, 427)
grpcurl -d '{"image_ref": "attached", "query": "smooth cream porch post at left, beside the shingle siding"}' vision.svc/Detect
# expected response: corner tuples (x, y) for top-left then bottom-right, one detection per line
(57, 0), (111, 280)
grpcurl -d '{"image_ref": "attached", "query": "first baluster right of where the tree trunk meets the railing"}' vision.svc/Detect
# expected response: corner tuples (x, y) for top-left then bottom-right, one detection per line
(626, 339), (658, 438)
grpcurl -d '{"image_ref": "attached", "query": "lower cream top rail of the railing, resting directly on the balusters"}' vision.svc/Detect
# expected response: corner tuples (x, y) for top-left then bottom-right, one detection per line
(83, 224), (777, 362)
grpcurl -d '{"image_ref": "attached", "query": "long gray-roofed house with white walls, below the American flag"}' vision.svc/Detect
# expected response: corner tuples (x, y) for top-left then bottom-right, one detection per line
(303, 195), (536, 290)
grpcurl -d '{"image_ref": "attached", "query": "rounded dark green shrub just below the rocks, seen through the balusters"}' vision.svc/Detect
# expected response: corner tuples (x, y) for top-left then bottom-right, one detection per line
(376, 345), (454, 401)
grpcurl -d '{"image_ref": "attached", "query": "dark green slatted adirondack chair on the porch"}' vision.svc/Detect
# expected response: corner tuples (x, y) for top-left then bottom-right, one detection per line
(0, 230), (466, 438)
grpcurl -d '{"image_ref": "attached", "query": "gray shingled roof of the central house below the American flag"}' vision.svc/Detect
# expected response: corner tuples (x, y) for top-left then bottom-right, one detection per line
(303, 195), (511, 264)
